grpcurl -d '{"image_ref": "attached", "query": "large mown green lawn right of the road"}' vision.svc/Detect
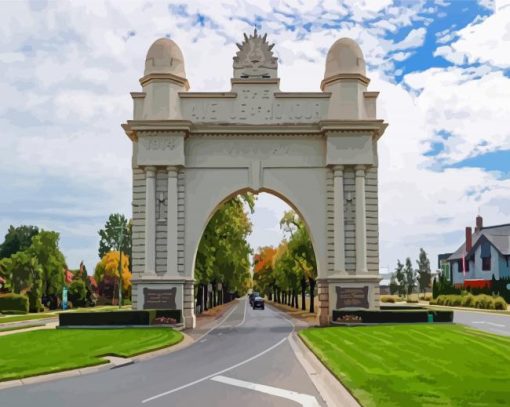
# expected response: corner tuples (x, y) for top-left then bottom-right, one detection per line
(300, 324), (510, 407)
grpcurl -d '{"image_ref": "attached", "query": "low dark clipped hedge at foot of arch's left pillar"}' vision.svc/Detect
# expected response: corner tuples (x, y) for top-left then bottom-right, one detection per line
(58, 310), (181, 326)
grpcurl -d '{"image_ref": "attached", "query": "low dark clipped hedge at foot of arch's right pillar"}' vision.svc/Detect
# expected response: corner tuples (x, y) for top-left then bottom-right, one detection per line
(333, 309), (453, 324)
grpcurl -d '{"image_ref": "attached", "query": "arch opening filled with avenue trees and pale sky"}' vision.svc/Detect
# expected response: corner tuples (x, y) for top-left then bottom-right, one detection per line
(193, 189), (318, 315)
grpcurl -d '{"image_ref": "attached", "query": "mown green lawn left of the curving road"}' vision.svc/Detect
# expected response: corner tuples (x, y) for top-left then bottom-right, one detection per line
(0, 328), (183, 381)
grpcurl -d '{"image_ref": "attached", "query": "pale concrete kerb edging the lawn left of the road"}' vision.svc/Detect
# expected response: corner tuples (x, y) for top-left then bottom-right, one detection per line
(0, 332), (194, 390)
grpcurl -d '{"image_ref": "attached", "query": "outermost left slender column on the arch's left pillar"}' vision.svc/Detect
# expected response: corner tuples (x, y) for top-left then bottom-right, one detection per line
(144, 166), (156, 275)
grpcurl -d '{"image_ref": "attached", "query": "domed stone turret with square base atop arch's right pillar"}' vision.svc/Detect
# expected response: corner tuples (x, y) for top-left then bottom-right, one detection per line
(321, 38), (378, 120)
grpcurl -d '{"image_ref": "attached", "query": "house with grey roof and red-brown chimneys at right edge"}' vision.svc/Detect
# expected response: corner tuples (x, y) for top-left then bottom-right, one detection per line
(448, 216), (510, 287)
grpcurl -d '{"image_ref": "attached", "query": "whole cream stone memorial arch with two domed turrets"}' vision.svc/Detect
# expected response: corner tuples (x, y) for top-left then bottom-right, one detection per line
(122, 31), (387, 327)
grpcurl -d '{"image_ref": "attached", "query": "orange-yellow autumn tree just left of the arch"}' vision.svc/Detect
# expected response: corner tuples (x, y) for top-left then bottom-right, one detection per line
(94, 251), (131, 302)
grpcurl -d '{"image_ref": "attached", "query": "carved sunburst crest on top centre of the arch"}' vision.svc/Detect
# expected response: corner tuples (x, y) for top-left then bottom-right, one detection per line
(234, 29), (278, 78)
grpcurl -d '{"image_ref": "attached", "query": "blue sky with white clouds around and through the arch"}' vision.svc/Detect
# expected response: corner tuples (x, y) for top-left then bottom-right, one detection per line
(0, 0), (510, 270)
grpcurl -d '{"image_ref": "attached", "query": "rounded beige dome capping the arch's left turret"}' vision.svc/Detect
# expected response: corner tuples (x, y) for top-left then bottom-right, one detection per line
(144, 38), (186, 78)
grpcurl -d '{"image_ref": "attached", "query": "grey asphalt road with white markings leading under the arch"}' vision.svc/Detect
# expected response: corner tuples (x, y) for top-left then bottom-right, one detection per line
(0, 299), (325, 407)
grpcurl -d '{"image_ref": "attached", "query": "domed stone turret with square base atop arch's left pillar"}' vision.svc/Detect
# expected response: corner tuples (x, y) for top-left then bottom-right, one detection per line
(131, 38), (189, 120)
